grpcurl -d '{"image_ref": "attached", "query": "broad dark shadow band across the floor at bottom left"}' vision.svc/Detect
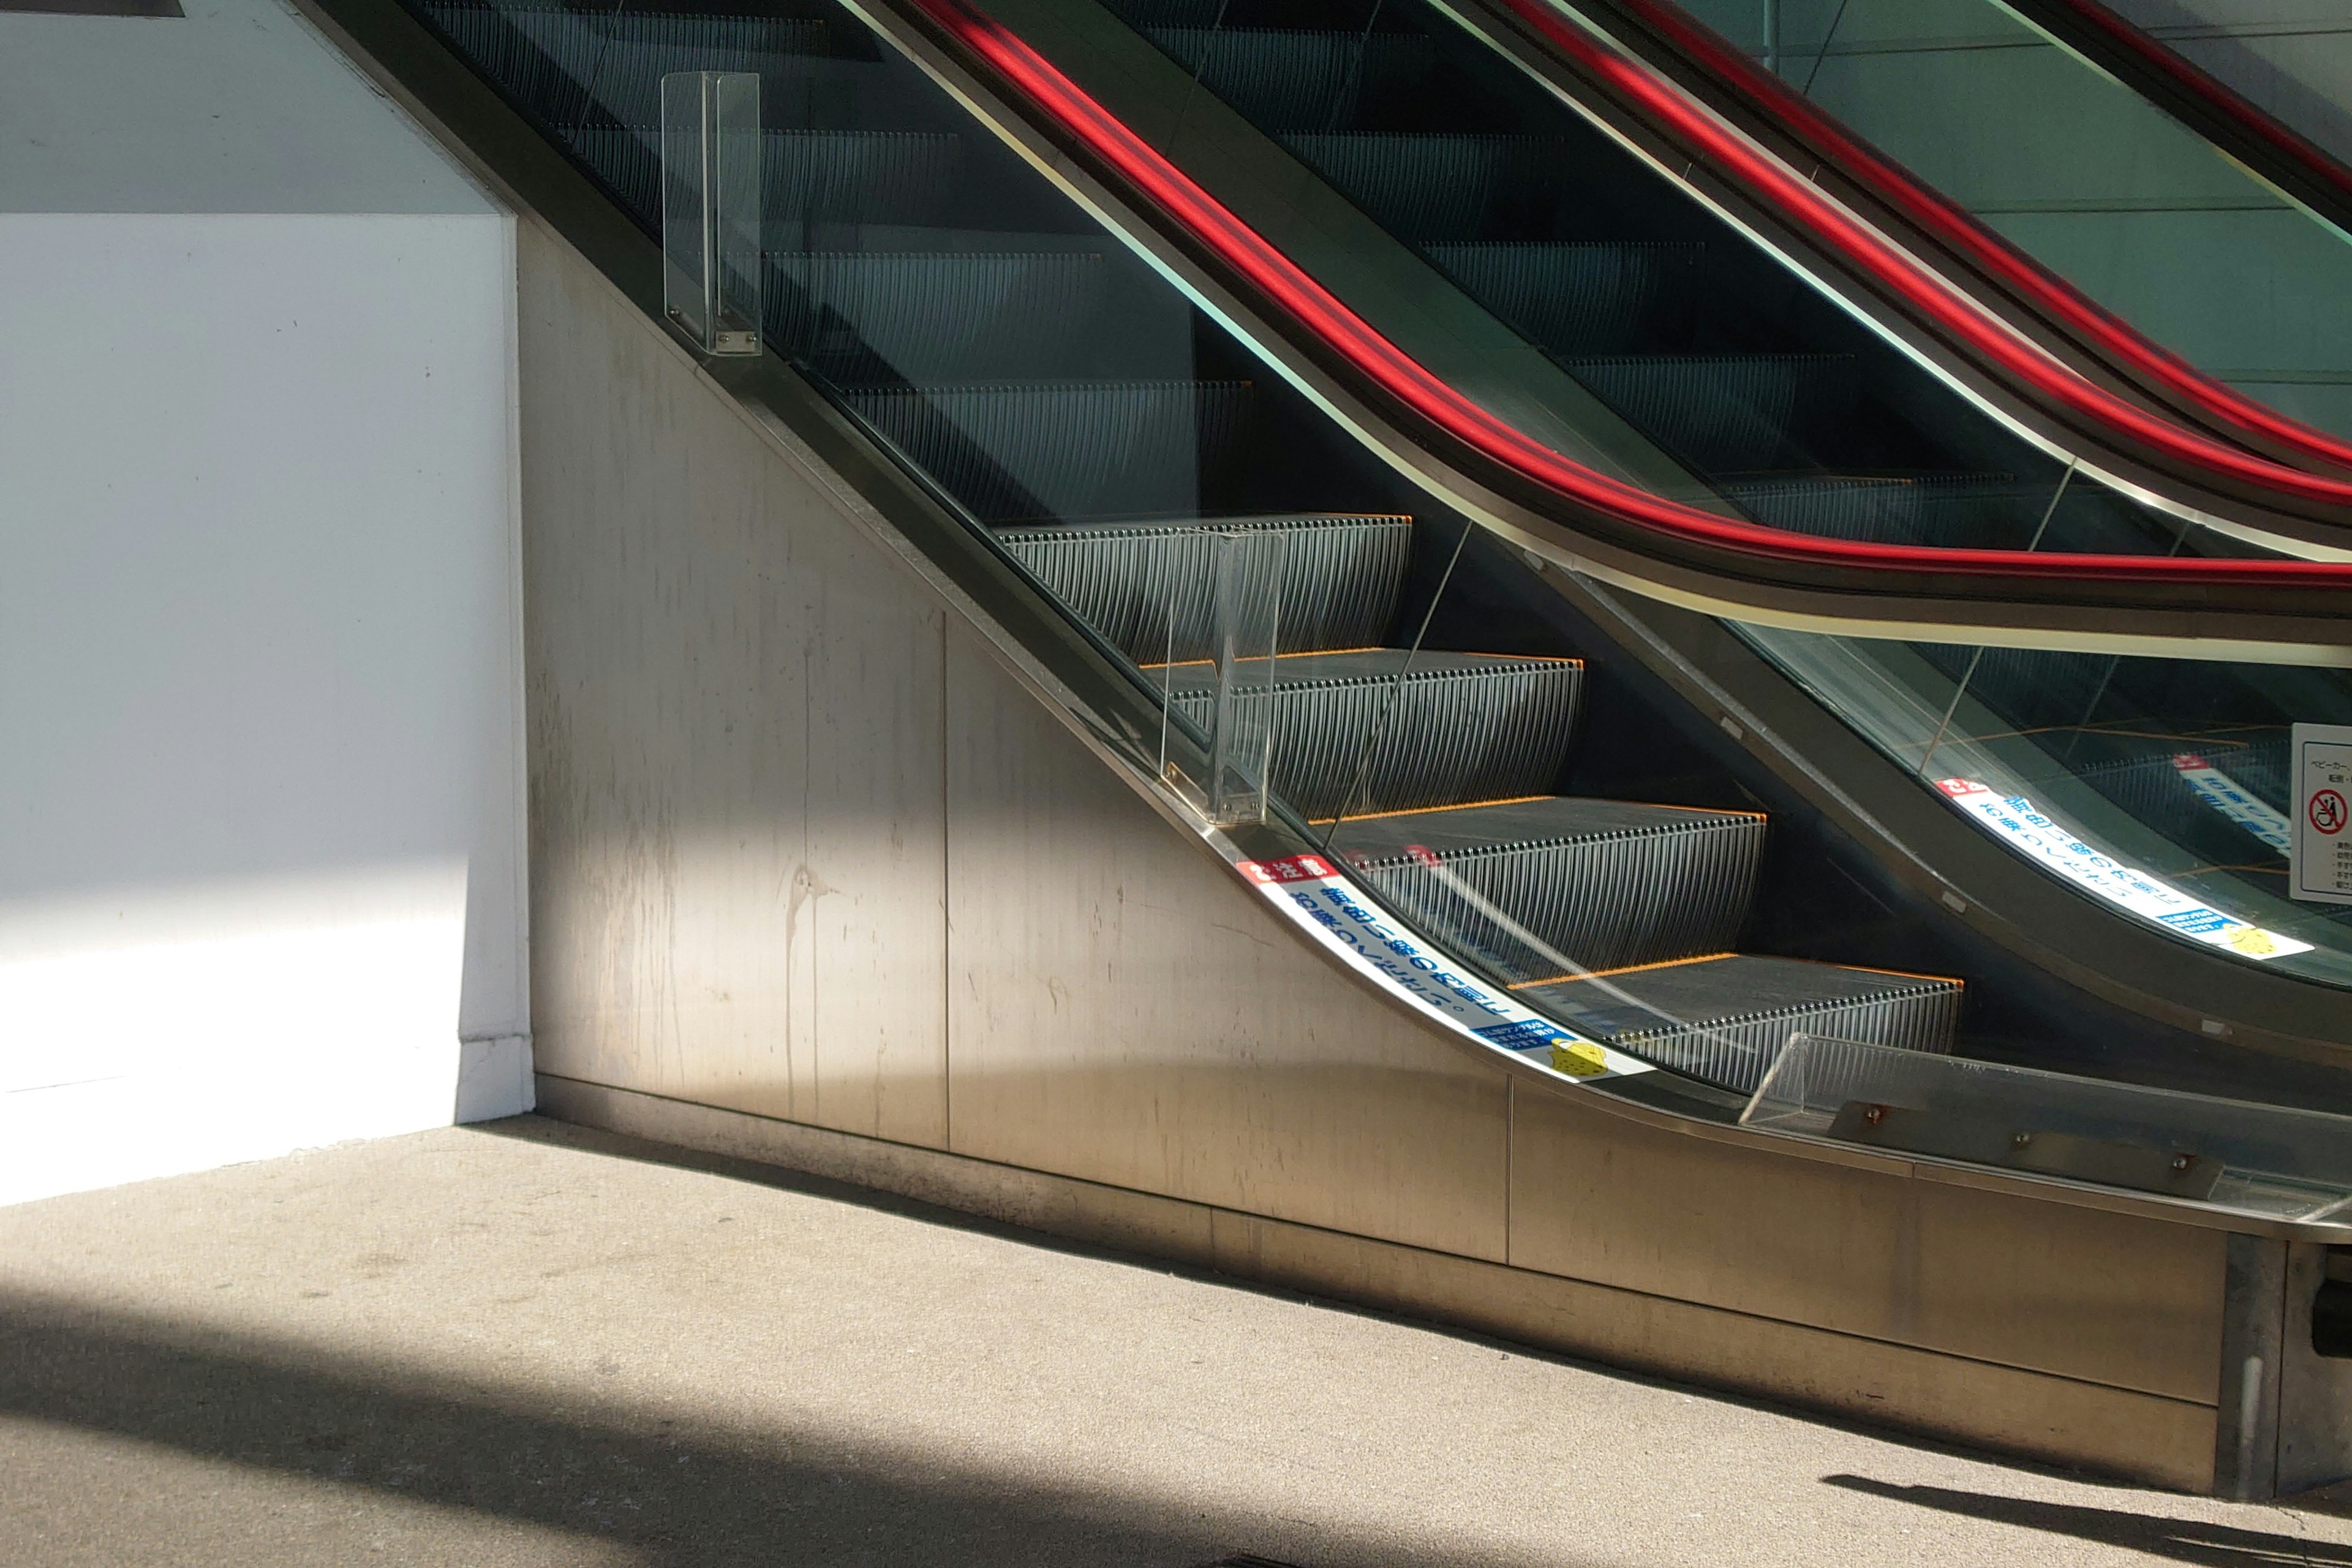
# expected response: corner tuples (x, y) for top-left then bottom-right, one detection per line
(0, 1291), (1472, 1568)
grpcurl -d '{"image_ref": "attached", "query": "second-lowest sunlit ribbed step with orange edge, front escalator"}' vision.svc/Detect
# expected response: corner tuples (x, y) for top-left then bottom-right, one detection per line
(1331, 794), (1764, 980)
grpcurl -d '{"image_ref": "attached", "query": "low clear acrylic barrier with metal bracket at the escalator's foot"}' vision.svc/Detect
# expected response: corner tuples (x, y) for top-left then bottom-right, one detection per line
(1741, 1035), (2352, 1220)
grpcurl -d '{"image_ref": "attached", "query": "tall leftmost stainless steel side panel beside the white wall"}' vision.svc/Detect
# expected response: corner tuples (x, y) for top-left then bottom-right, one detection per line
(518, 224), (948, 1145)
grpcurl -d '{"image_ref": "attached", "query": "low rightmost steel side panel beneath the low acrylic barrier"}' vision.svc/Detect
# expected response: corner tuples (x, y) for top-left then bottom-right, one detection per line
(1510, 1088), (2227, 1406)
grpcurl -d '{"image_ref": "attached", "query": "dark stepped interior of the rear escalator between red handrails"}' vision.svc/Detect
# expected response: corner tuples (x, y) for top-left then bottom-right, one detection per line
(1091, 0), (2197, 555)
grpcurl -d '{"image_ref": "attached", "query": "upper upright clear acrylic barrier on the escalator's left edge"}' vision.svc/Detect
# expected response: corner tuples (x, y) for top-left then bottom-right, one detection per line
(661, 70), (764, 355)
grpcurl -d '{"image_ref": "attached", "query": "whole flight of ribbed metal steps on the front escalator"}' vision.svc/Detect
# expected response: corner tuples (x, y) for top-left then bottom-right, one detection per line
(404, 0), (1959, 1091)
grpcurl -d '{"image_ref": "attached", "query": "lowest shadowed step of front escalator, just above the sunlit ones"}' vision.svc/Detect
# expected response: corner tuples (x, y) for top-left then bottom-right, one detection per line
(842, 381), (1249, 522)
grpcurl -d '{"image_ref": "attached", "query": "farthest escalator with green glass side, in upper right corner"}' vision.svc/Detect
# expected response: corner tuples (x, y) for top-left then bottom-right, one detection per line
(1599, 0), (2352, 466)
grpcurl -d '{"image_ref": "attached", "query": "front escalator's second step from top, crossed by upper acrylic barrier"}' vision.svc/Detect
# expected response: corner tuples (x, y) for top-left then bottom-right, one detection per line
(574, 123), (964, 236)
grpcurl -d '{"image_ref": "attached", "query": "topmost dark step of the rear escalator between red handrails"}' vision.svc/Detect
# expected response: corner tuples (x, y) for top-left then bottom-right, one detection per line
(1143, 26), (1437, 132)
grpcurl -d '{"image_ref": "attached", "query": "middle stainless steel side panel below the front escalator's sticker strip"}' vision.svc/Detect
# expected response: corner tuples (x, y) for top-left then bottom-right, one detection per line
(948, 630), (1507, 1260)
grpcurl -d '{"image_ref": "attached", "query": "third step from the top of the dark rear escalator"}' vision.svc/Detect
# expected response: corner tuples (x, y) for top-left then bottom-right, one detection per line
(1420, 239), (1708, 355)
